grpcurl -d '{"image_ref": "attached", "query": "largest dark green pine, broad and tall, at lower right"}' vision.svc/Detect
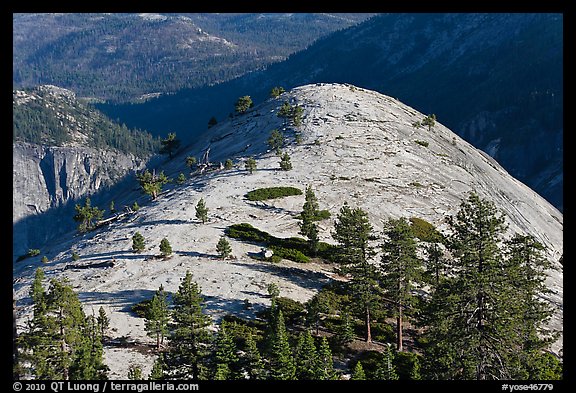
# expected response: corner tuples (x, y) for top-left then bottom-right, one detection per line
(424, 193), (547, 379)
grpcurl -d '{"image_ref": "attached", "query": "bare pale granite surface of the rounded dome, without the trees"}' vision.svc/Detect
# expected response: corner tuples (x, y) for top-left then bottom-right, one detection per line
(14, 84), (563, 378)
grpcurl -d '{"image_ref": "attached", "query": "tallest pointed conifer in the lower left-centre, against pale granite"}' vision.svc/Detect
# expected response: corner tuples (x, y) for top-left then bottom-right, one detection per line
(164, 271), (211, 379)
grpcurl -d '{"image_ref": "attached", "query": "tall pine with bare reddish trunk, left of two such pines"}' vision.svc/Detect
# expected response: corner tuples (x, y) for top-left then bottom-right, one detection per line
(332, 203), (380, 343)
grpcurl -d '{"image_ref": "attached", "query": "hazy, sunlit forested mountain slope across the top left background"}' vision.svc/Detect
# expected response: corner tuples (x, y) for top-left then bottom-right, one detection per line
(12, 13), (373, 101)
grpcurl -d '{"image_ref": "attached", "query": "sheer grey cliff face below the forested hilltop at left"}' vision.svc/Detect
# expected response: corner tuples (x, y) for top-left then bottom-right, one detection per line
(12, 142), (146, 256)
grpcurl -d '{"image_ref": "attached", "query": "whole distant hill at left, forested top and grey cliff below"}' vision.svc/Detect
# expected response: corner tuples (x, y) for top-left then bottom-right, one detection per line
(12, 85), (160, 255)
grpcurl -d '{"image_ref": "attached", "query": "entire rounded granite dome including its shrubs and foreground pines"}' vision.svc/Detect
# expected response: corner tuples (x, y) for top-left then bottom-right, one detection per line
(13, 83), (563, 380)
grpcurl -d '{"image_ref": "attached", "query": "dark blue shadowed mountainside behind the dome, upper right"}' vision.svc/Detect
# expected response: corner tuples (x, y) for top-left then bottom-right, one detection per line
(95, 13), (564, 209)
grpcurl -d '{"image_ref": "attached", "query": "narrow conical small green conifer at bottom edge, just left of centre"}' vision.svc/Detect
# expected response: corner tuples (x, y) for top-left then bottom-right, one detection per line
(269, 310), (296, 380)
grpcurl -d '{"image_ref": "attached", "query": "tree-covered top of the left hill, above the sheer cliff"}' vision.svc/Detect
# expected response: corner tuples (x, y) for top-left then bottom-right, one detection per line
(12, 90), (160, 157)
